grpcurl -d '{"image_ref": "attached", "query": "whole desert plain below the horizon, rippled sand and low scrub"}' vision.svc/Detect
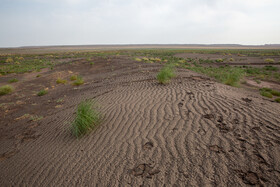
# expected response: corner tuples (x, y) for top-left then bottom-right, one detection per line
(0, 46), (280, 186)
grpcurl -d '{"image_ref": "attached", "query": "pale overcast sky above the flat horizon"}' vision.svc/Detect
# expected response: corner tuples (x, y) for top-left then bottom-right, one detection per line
(0, 0), (280, 47)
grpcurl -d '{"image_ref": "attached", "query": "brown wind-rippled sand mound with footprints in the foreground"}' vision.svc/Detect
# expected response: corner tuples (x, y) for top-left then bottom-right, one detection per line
(0, 56), (280, 186)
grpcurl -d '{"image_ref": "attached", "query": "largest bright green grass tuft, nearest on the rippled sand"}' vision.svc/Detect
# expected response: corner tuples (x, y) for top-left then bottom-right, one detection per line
(71, 100), (101, 137)
